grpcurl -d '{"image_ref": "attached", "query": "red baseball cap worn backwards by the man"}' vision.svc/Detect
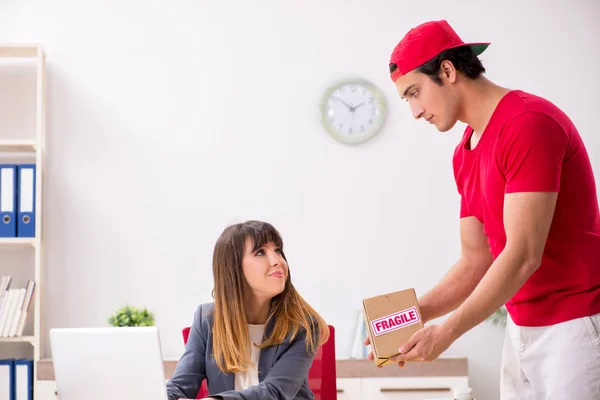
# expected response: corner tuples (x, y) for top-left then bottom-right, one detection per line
(390, 20), (490, 82)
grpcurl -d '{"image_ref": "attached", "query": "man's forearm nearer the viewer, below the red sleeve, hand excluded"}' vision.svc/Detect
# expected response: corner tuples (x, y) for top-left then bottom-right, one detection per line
(444, 249), (539, 338)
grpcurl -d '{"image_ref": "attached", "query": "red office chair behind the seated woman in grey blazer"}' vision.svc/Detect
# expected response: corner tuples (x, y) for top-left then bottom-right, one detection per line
(182, 325), (337, 400)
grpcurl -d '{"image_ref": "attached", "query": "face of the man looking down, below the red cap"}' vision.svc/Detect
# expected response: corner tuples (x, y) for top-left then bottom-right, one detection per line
(396, 66), (458, 132)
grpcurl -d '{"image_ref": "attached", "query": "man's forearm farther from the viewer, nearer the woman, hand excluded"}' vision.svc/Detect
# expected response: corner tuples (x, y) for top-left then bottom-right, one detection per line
(419, 257), (492, 322)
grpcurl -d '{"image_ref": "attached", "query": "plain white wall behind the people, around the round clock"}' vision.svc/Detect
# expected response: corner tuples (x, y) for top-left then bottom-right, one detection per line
(0, 0), (600, 399)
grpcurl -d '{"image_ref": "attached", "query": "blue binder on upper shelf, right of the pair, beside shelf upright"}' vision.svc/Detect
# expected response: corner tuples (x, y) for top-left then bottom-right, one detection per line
(17, 164), (36, 237)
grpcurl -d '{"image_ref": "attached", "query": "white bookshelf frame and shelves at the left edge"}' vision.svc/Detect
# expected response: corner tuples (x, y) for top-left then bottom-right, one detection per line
(0, 43), (46, 396)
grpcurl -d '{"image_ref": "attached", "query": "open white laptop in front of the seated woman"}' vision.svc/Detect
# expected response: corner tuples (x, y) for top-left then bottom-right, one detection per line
(50, 327), (168, 400)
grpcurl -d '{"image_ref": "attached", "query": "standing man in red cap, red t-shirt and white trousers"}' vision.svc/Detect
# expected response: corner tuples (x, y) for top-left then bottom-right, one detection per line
(366, 20), (600, 400)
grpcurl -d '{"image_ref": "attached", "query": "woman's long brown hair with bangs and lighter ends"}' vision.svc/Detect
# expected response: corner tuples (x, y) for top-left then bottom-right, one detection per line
(212, 221), (329, 373)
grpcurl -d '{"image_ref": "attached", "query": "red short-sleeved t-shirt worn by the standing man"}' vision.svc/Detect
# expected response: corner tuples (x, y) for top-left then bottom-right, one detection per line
(453, 90), (600, 326)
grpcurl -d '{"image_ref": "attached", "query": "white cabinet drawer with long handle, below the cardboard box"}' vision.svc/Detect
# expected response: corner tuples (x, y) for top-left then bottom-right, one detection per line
(362, 377), (468, 400)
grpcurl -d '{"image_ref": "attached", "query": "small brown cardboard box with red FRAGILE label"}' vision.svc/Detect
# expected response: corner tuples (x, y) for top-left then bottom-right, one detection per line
(363, 289), (423, 367)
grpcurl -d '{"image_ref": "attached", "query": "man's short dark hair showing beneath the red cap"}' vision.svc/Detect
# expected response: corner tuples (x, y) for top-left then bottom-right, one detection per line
(390, 46), (485, 85)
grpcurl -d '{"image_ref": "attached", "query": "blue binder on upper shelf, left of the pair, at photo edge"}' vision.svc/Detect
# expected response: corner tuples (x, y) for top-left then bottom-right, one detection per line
(0, 164), (18, 237)
